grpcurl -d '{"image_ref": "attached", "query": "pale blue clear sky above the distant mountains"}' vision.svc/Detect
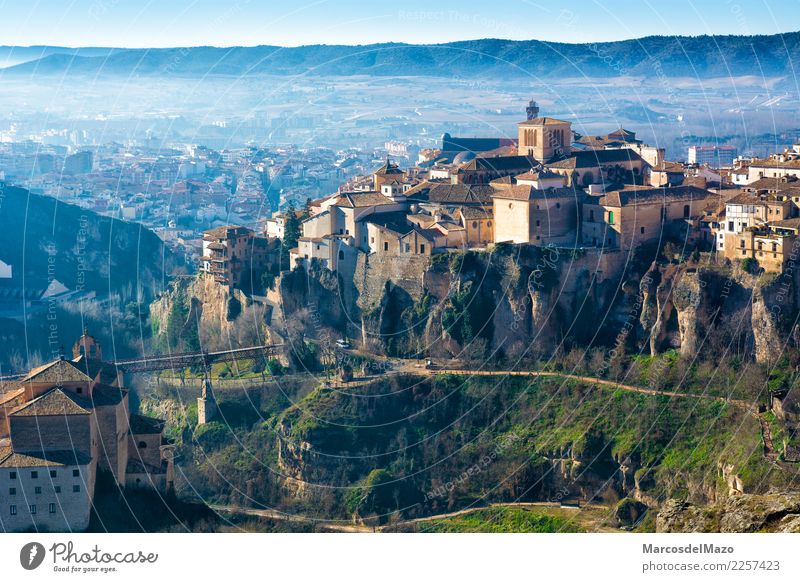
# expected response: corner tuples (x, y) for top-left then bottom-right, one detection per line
(0, 0), (800, 48)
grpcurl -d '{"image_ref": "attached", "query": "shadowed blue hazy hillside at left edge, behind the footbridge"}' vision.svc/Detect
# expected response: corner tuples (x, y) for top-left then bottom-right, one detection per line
(0, 184), (183, 372)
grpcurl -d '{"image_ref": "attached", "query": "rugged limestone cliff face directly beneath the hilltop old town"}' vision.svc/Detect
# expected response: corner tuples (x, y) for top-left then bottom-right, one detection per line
(280, 245), (800, 363)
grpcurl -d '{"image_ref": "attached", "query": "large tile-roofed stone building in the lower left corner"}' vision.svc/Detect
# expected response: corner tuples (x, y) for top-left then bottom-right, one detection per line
(0, 333), (172, 531)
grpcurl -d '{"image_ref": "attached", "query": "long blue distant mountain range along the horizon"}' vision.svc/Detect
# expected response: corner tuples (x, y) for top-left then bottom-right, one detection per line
(0, 32), (800, 79)
